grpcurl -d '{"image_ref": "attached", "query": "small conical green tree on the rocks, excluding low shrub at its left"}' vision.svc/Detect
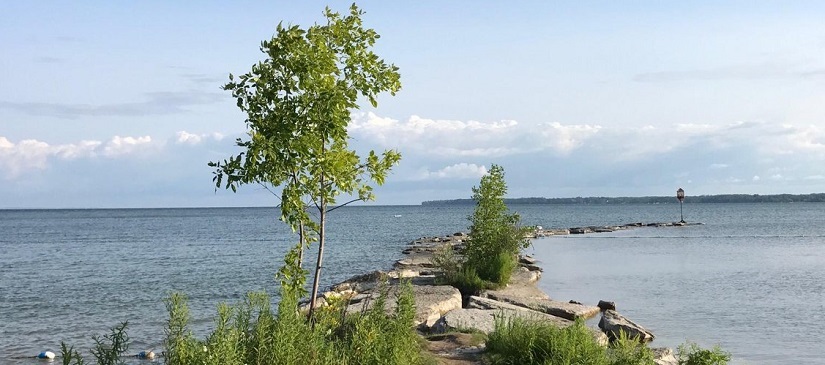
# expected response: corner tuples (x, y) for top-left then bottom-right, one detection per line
(464, 164), (530, 285)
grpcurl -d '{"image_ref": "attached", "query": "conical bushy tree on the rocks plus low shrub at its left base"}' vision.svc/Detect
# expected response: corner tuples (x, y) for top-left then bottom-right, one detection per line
(433, 164), (530, 296)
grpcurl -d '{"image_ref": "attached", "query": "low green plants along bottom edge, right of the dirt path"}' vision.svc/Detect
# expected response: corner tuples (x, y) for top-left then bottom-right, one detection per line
(486, 317), (730, 365)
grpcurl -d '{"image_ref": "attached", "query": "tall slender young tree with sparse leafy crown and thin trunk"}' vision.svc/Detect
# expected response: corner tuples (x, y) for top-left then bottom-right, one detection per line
(209, 4), (401, 318)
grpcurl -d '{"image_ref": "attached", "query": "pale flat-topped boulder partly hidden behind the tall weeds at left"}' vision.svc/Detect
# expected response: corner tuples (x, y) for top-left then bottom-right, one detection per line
(347, 285), (461, 327)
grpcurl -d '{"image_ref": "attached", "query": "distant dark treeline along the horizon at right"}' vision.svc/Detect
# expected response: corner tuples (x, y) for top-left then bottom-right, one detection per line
(421, 193), (825, 205)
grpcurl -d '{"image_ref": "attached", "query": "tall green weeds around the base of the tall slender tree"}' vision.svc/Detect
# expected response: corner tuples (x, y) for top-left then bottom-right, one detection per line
(160, 283), (424, 365)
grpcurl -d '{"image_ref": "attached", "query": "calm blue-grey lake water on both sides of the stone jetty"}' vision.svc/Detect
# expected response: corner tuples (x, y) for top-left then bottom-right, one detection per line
(0, 204), (825, 364)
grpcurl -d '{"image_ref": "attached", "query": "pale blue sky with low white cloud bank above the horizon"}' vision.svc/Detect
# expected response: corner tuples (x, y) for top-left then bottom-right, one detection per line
(0, 1), (825, 208)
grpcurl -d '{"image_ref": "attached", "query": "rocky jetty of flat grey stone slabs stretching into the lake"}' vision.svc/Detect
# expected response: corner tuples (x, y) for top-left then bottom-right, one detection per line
(318, 222), (699, 365)
